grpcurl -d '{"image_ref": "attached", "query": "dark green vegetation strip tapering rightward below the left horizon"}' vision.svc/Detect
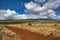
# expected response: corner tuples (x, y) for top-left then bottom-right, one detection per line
(0, 20), (36, 24)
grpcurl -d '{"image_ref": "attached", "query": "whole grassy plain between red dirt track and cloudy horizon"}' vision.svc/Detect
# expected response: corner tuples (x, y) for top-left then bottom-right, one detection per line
(0, 20), (60, 40)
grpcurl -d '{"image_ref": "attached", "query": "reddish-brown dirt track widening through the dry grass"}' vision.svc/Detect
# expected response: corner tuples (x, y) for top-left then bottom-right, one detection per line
(5, 26), (60, 40)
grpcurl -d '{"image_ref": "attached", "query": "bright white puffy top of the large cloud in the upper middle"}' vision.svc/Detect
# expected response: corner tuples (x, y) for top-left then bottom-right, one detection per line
(25, 1), (44, 12)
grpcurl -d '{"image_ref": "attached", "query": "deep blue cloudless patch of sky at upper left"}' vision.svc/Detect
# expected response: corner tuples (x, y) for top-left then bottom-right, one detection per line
(0, 0), (32, 14)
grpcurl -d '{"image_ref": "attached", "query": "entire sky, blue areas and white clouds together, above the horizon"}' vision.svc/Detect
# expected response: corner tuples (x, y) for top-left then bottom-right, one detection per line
(0, 0), (60, 20)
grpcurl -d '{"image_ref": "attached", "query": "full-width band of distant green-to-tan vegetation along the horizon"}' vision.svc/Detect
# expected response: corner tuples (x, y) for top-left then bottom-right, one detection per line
(0, 19), (60, 24)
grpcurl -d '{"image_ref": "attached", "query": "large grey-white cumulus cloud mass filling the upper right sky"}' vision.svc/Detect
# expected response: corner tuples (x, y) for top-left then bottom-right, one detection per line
(25, 0), (60, 19)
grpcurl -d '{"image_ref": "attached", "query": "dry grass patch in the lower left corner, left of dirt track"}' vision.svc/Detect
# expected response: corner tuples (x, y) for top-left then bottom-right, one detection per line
(0, 25), (21, 40)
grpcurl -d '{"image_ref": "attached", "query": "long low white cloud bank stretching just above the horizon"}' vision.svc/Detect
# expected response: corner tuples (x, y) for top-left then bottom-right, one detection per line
(0, 9), (60, 20)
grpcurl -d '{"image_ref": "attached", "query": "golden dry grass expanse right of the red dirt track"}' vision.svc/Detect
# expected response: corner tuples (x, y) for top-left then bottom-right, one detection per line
(0, 22), (60, 37)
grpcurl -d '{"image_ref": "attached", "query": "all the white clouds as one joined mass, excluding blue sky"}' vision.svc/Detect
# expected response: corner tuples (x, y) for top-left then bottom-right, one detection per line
(0, 0), (60, 20)
